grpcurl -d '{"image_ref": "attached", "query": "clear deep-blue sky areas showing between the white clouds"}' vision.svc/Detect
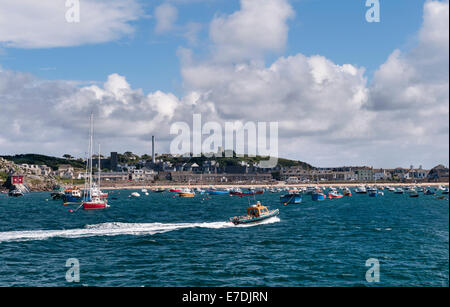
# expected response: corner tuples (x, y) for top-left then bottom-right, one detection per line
(0, 0), (424, 95)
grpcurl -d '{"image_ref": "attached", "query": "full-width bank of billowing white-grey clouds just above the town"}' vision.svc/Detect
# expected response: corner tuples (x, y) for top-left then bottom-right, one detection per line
(0, 0), (449, 167)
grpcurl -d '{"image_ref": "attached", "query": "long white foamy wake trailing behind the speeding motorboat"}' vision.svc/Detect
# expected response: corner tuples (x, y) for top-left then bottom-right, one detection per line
(0, 217), (280, 243)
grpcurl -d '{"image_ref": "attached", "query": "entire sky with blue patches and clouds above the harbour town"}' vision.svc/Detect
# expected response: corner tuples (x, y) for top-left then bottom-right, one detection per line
(0, 0), (449, 167)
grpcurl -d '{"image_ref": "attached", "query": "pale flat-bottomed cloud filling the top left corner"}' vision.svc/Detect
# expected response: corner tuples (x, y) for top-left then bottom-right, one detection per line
(0, 0), (141, 48)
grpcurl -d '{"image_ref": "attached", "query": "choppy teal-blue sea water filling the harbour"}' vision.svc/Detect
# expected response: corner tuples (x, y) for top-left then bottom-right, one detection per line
(0, 190), (449, 286)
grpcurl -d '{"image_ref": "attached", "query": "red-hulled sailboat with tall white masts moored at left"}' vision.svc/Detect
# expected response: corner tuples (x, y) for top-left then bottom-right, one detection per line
(82, 114), (109, 210)
